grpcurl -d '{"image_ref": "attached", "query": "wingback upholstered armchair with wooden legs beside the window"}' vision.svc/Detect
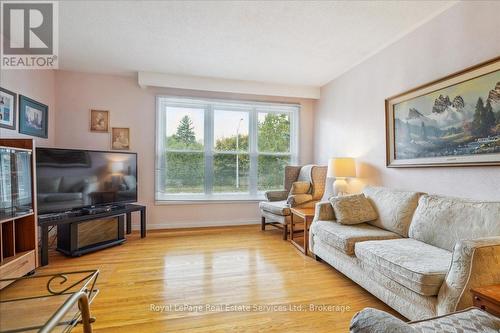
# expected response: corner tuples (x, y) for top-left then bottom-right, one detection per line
(259, 165), (327, 240)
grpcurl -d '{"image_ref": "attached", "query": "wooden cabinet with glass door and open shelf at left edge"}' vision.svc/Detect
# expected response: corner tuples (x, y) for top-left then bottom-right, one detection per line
(0, 139), (38, 289)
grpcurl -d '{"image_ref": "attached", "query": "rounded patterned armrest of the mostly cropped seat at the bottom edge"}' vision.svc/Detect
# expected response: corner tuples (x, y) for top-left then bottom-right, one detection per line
(349, 308), (419, 333)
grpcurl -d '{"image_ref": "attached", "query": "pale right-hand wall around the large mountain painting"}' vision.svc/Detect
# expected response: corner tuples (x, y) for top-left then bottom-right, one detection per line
(315, 2), (500, 200)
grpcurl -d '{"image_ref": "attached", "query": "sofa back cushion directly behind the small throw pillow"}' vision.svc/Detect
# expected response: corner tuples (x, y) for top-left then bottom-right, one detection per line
(363, 186), (421, 237)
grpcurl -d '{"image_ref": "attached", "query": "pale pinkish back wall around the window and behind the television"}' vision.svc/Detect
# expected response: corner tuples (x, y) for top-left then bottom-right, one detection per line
(55, 71), (314, 227)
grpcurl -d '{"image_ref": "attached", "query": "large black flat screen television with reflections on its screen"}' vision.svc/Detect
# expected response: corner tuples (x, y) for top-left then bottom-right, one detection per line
(36, 148), (137, 214)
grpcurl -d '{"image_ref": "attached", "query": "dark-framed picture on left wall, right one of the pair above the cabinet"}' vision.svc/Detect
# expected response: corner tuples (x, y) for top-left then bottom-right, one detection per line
(19, 95), (49, 138)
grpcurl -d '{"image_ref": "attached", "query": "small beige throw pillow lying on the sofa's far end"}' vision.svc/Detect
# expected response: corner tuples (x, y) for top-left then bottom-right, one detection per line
(330, 194), (377, 224)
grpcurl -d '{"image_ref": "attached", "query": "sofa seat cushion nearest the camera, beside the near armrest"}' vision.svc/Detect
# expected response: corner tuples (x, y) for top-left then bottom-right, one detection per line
(354, 238), (452, 296)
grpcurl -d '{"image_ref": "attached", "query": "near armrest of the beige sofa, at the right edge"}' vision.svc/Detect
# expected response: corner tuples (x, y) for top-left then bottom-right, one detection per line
(437, 236), (500, 315)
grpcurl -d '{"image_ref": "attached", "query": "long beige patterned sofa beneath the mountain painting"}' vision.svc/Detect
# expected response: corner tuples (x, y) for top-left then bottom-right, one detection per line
(309, 187), (500, 320)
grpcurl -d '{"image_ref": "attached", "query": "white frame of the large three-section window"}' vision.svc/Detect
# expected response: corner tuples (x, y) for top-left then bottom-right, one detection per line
(155, 95), (300, 204)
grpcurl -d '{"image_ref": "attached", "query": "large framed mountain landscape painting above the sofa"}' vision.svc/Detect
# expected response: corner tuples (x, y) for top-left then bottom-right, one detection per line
(385, 57), (500, 167)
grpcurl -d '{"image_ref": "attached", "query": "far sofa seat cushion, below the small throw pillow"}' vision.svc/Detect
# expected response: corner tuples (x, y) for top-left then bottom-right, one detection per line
(311, 221), (400, 256)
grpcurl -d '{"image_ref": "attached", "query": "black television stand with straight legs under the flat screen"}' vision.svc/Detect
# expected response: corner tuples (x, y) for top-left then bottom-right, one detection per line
(38, 204), (146, 266)
